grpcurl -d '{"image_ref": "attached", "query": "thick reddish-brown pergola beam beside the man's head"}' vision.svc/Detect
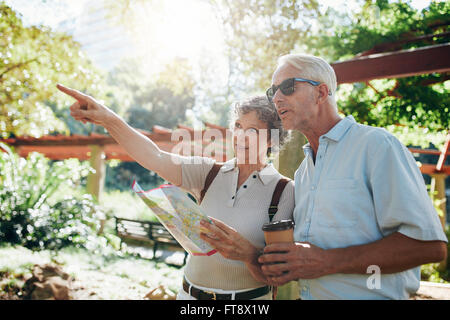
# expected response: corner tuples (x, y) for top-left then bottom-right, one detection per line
(331, 43), (450, 84)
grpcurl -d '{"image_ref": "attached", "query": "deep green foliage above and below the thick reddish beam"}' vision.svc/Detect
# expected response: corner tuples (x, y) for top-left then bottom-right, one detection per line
(305, 0), (450, 147)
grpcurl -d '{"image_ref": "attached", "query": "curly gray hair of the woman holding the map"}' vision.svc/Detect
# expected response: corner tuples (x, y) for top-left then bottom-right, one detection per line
(230, 96), (288, 156)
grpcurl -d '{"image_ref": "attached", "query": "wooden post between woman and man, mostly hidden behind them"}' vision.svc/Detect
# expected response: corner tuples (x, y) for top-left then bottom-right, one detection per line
(274, 131), (306, 300)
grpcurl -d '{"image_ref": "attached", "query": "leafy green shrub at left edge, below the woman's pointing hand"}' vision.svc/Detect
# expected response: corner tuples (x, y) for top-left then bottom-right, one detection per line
(0, 143), (106, 249)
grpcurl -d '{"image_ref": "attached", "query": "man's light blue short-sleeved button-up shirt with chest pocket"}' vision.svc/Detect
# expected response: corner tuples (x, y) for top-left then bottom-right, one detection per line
(294, 116), (447, 299)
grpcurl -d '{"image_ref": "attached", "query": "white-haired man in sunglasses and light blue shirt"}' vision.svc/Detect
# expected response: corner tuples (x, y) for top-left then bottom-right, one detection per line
(259, 54), (448, 299)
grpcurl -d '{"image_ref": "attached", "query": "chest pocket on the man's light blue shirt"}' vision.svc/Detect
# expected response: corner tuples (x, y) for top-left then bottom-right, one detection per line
(314, 179), (358, 228)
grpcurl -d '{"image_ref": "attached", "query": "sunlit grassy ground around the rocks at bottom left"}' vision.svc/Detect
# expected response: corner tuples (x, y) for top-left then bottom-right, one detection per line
(0, 244), (183, 300)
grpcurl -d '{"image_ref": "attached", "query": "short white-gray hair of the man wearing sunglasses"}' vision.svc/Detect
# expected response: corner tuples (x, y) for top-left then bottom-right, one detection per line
(278, 54), (337, 104)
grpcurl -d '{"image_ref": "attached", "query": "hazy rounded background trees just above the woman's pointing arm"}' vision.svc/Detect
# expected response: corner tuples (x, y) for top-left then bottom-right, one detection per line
(108, 59), (195, 131)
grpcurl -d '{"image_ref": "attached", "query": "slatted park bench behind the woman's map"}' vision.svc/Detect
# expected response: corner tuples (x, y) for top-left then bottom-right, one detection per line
(115, 217), (188, 265)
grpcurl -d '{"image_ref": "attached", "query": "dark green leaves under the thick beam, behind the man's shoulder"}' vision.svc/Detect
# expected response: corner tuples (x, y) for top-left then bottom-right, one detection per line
(337, 75), (450, 148)
